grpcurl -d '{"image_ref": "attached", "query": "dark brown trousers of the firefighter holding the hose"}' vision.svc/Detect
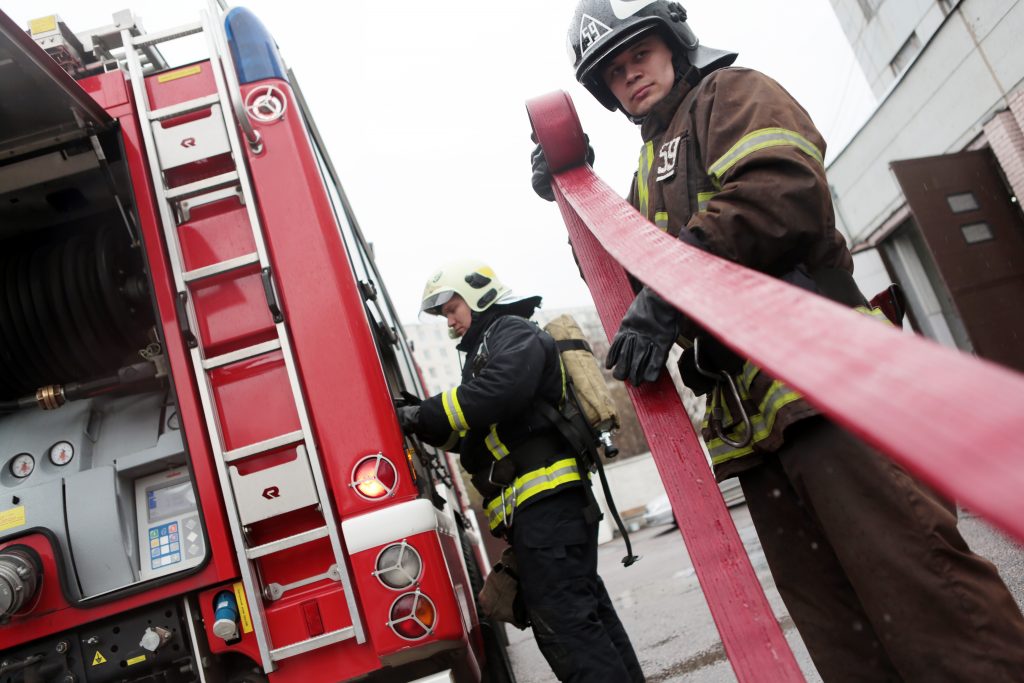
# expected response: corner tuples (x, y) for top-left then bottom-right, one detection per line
(739, 418), (1024, 683)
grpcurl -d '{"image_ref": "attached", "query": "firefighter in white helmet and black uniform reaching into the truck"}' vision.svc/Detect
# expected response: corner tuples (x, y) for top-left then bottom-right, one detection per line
(398, 261), (644, 683)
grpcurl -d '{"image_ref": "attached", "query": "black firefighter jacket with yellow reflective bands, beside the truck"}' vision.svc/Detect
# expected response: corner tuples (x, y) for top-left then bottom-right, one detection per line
(418, 305), (583, 536)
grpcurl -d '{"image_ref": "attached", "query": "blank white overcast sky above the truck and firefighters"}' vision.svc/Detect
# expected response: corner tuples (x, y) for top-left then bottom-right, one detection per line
(0, 0), (874, 322)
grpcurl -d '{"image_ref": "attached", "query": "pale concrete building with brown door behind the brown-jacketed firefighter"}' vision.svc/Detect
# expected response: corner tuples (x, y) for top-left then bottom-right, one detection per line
(828, 0), (1024, 370)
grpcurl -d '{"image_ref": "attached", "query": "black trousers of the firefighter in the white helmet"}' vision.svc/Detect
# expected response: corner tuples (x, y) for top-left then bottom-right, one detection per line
(512, 487), (644, 683)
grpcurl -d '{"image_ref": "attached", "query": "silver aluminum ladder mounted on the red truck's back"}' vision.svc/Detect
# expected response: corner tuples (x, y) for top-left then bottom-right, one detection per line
(122, 6), (366, 673)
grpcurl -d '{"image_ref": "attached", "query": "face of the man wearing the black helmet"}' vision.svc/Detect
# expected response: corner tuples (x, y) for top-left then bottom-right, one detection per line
(601, 34), (676, 116)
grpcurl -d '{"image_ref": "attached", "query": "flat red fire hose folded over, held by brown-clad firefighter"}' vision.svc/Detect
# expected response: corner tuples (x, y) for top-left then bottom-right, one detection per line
(527, 92), (1024, 681)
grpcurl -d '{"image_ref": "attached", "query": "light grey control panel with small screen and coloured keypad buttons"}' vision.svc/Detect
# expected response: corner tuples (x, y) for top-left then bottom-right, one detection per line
(135, 467), (206, 581)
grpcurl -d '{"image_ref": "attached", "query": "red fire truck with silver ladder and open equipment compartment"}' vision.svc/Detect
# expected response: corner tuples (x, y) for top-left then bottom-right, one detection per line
(0, 5), (511, 683)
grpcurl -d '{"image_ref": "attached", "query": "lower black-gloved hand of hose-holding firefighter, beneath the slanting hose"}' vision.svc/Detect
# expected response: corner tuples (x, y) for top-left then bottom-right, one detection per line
(604, 287), (682, 386)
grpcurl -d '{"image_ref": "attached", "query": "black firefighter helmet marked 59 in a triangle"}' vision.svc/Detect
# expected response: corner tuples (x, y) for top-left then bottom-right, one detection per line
(568, 0), (736, 112)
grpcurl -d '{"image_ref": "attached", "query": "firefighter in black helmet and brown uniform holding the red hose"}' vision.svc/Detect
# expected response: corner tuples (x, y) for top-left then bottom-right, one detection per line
(532, 0), (1024, 682)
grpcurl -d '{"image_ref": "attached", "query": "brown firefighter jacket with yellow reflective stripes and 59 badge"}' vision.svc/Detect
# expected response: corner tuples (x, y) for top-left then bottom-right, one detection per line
(629, 68), (853, 480)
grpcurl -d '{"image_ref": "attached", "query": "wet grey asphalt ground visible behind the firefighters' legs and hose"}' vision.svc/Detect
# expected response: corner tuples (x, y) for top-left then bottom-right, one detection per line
(508, 505), (1024, 683)
